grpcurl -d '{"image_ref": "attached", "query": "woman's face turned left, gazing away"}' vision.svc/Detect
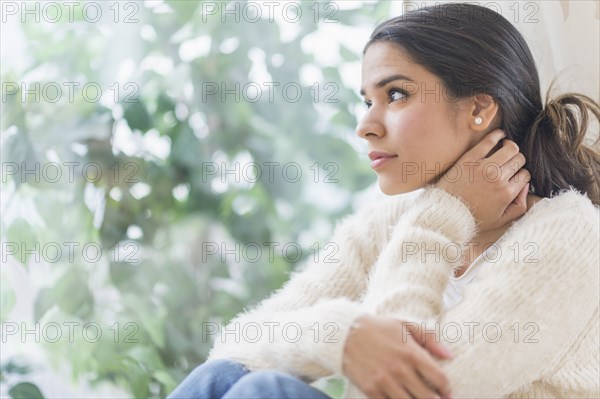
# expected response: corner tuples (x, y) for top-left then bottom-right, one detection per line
(356, 42), (489, 195)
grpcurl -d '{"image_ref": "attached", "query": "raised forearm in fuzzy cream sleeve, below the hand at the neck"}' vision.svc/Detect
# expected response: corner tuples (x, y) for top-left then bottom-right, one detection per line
(364, 186), (475, 320)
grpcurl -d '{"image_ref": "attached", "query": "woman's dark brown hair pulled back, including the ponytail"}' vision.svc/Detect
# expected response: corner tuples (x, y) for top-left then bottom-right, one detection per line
(363, 3), (600, 205)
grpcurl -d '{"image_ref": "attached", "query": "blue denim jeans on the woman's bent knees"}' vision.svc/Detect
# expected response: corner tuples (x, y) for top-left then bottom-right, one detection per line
(167, 359), (331, 399)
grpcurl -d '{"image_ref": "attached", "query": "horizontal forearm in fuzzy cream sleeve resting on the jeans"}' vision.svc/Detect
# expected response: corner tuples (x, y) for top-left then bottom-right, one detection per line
(208, 298), (366, 380)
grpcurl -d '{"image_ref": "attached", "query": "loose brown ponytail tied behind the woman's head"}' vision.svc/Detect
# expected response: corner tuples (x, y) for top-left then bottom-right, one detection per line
(523, 89), (600, 205)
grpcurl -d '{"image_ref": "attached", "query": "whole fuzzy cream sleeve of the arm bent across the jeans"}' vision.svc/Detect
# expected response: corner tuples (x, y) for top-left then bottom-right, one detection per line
(207, 202), (384, 381)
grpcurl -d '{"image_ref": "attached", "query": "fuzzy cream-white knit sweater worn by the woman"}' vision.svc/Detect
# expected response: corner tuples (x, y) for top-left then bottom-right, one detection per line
(208, 186), (600, 398)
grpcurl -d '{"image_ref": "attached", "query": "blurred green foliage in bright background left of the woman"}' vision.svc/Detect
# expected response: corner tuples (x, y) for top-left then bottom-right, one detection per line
(1, 1), (389, 398)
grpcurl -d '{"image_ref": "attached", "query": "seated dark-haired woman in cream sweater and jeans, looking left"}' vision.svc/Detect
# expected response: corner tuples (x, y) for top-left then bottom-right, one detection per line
(171, 3), (600, 398)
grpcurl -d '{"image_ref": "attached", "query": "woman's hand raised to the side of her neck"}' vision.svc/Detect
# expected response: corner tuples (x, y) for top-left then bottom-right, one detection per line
(434, 129), (531, 231)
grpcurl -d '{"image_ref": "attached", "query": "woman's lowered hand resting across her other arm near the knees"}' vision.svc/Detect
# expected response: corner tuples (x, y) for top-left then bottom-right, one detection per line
(343, 315), (450, 398)
